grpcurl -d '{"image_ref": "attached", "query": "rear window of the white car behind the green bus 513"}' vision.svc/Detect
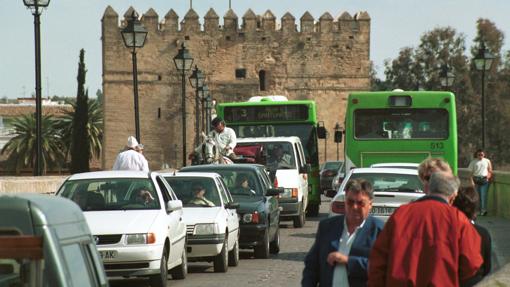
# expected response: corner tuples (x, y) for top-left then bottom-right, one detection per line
(349, 173), (423, 193)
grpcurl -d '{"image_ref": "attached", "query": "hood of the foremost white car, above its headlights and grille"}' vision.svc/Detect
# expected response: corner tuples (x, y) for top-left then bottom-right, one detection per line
(83, 210), (160, 235)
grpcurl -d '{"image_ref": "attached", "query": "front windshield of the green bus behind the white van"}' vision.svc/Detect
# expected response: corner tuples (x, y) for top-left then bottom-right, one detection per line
(229, 124), (318, 163)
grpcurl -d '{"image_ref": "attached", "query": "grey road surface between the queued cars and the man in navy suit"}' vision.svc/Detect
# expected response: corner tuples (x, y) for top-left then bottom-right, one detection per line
(110, 199), (329, 287)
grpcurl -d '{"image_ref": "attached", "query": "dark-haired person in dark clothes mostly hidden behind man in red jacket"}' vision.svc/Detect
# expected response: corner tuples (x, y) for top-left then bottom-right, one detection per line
(453, 186), (492, 287)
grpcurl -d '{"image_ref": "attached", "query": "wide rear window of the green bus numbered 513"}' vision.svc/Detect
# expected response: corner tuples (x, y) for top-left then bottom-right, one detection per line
(354, 109), (449, 140)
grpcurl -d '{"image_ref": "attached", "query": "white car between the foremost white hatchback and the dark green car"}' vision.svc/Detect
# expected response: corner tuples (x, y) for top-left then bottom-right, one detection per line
(163, 172), (239, 272)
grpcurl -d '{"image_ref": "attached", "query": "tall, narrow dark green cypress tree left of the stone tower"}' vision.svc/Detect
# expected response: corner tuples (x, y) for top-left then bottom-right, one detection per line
(71, 49), (90, 173)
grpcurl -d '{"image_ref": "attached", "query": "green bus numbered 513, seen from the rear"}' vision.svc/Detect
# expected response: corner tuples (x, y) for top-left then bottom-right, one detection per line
(344, 90), (457, 174)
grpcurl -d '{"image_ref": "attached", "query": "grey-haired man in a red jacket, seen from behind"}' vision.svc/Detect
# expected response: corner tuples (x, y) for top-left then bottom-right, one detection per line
(368, 172), (483, 286)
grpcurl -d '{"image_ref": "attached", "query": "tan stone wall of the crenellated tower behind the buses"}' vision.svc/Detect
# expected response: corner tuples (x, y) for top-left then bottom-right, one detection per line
(102, 7), (370, 170)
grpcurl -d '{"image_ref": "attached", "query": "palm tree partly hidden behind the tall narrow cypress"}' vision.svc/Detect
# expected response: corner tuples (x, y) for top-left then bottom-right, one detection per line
(58, 100), (103, 162)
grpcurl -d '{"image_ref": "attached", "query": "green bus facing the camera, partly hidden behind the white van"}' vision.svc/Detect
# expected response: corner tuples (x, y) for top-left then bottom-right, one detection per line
(216, 96), (325, 216)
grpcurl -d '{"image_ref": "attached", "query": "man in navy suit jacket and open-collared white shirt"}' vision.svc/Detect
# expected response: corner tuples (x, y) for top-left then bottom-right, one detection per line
(301, 179), (384, 287)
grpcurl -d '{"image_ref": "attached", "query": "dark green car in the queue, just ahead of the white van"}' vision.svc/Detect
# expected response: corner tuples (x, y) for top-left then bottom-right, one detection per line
(180, 164), (283, 258)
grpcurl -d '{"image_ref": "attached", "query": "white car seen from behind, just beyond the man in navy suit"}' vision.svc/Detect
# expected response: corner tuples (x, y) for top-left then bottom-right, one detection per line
(329, 167), (425, 221)
